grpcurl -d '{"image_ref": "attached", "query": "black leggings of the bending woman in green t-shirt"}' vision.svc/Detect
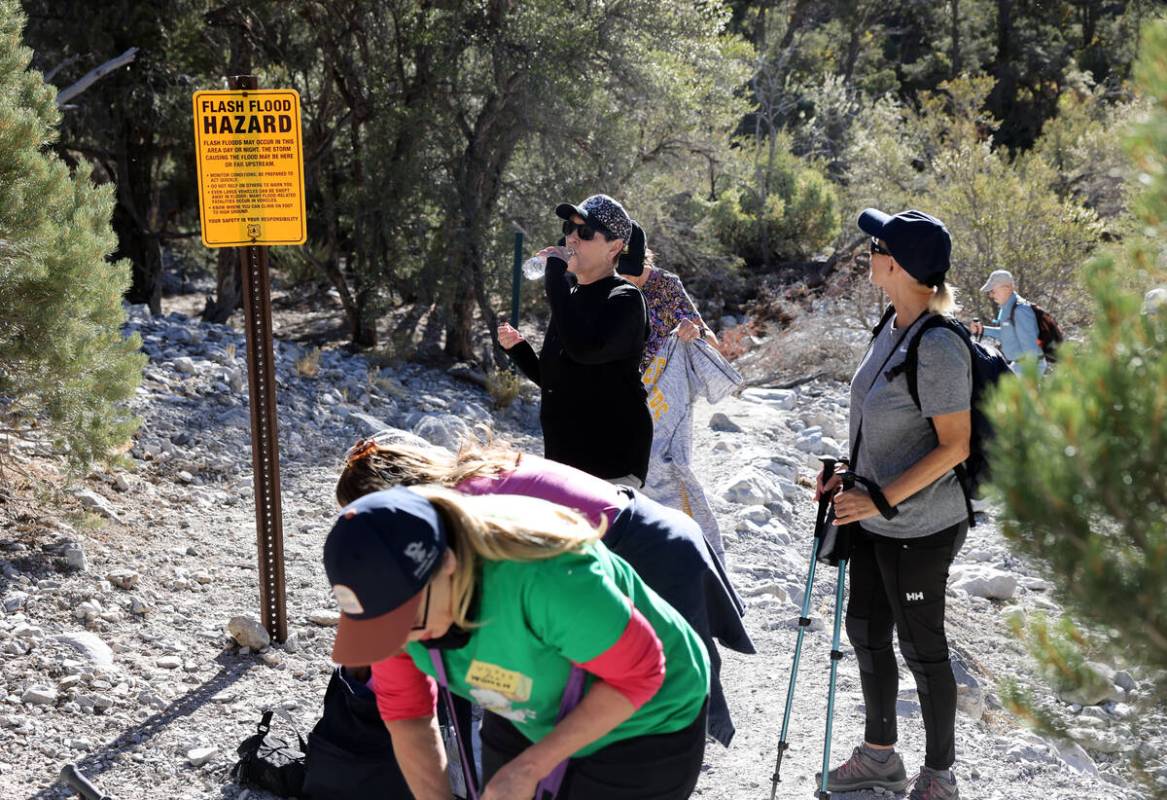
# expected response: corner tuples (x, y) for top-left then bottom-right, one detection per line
(482, 701), (708, 800)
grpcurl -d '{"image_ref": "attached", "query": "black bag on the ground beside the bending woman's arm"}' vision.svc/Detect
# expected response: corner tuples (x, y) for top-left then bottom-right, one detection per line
(301, 667), (413, 800)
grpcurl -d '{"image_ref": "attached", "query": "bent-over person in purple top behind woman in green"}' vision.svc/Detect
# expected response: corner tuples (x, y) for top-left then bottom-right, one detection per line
(336, 437), (756, 746)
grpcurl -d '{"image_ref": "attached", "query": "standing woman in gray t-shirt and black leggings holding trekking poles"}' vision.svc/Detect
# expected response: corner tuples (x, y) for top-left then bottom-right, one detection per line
(819, 209), (972, 800)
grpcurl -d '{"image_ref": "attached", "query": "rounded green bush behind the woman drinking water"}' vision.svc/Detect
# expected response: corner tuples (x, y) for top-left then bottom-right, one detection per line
(711, 136), (839, 265)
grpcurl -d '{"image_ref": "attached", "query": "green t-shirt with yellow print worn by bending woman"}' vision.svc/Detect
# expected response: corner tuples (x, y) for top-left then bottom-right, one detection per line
(406, 542), (710, 756)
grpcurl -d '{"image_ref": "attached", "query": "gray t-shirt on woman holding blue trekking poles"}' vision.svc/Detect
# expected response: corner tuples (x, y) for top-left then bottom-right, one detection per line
(851, 314), (972, 539)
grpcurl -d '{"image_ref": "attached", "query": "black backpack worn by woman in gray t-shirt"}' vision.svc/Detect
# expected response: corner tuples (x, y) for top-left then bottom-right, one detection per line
(872, 306), (1013, 526)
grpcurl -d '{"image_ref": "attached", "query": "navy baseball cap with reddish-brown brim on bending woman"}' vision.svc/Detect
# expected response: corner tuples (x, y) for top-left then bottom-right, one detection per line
(324, 486), (447, 667)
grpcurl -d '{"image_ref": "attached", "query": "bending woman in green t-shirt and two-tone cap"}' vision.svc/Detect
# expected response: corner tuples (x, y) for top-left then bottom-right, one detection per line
(324, 486), (710, 800)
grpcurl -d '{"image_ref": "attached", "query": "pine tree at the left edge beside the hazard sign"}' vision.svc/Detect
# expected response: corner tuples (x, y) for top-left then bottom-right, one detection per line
(0, 0), (144, 464)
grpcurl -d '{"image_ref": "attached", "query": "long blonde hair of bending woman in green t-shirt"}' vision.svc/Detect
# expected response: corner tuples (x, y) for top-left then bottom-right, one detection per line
(413, 486), (603, 630)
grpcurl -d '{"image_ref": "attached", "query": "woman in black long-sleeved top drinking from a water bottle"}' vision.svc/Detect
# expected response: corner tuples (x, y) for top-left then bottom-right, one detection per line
(498, 195), (652, 489)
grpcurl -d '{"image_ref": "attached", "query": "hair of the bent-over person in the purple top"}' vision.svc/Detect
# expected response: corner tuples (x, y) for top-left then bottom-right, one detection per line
(336, 440), (522, 506)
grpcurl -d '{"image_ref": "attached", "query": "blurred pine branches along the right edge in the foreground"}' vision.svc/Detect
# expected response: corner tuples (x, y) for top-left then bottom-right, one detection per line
(990, 10), (1167, 783)
